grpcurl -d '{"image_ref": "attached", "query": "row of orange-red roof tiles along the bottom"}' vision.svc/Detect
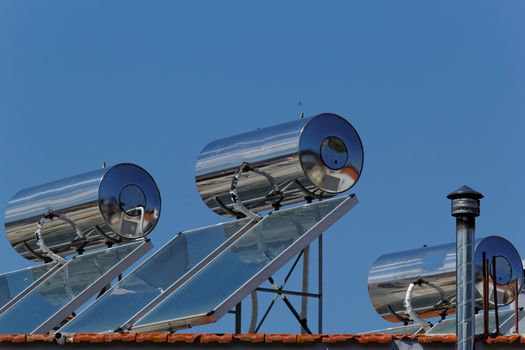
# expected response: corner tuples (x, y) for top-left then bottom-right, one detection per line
(0, 334), (525, 344)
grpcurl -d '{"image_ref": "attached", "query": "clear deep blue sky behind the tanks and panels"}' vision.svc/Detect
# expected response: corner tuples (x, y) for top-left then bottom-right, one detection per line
(0, 0), (525, 333)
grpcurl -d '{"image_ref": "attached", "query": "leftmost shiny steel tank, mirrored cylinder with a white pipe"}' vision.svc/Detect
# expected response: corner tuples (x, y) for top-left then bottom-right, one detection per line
(5, 163), (161, 260)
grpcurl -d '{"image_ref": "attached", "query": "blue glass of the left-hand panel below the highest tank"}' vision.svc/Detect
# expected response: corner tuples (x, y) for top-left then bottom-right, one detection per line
(60, 219), (250, 333)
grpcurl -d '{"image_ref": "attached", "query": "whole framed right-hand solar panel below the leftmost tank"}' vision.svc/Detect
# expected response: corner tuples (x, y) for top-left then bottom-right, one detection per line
(0, 241), (151, 334)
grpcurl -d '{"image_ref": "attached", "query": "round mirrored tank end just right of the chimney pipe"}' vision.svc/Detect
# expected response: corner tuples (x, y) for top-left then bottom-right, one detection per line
(474, 236), (523, 305)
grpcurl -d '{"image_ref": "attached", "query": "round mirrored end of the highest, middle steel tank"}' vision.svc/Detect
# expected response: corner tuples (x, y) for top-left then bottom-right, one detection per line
(299, 113), (364, 194)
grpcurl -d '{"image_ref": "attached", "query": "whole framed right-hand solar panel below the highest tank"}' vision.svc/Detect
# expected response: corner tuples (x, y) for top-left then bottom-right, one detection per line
(128, 196), (357, 332)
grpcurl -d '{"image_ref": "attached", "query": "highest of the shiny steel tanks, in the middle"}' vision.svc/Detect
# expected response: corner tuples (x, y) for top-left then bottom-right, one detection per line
(195, 113), (363, 217)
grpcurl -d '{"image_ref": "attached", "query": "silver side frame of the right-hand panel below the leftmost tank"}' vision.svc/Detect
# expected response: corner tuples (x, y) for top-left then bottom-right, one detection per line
(31, 238), (153, 334)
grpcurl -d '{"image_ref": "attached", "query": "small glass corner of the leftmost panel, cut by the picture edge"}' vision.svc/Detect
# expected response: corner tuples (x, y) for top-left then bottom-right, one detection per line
(0, 263), (55, 307)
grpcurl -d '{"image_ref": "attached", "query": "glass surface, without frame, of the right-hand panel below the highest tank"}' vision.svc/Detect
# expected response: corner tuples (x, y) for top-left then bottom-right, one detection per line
(136, 198), (345, 326)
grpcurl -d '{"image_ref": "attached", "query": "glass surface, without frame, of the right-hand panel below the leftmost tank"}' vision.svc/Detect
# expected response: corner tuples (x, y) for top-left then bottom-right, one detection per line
(0, 242), (142, 334)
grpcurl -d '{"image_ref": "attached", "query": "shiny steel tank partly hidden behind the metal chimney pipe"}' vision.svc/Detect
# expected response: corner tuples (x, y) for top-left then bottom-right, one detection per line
(368, 236), (523, 322)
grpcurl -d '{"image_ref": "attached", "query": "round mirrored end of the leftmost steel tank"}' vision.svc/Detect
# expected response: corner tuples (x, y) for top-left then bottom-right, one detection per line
(98, 163), (161, 239)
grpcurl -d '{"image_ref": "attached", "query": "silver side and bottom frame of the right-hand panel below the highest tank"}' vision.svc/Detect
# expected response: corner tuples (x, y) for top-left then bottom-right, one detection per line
(128, 194), (358, 333)
